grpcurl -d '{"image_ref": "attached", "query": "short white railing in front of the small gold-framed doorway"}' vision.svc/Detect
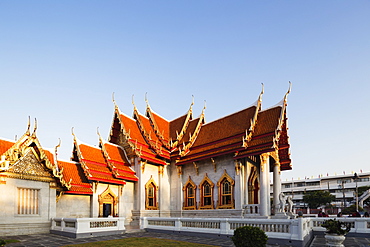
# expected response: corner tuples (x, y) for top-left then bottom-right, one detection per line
(51, 217), (125, 235)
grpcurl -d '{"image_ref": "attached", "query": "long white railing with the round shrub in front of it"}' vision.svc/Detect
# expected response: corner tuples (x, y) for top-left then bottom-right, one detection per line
(141, 217), (311, 241)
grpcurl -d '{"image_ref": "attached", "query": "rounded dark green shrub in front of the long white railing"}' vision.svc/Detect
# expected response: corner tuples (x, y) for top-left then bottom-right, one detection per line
(231, 226), (267, 247)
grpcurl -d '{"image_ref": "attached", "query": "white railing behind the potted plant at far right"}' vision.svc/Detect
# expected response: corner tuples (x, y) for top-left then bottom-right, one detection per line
(310, 217), (370, 234)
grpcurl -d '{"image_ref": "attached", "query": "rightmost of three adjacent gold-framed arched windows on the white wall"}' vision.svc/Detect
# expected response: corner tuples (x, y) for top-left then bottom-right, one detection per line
(217, 170), (234, 209)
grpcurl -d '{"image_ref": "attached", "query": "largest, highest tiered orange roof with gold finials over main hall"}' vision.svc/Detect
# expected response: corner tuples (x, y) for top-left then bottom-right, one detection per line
(110, 85), (291, 170)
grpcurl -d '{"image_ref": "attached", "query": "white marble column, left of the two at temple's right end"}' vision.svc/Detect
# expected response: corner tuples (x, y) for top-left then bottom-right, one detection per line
(260, 153), (270, 216)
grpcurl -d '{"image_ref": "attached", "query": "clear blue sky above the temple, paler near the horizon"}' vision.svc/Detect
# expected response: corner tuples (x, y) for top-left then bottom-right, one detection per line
(0, 0), (370, 179)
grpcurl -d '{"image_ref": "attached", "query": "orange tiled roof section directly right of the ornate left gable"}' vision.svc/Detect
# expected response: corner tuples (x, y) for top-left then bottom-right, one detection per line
(58, 160), (93, 195)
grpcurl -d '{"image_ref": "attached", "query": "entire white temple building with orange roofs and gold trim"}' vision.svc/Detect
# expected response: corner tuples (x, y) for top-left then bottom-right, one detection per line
(0, 85), (292, 235)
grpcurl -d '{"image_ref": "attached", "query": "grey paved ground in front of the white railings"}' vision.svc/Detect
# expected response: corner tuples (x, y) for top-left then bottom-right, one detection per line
(3, 232), (370, 247)
